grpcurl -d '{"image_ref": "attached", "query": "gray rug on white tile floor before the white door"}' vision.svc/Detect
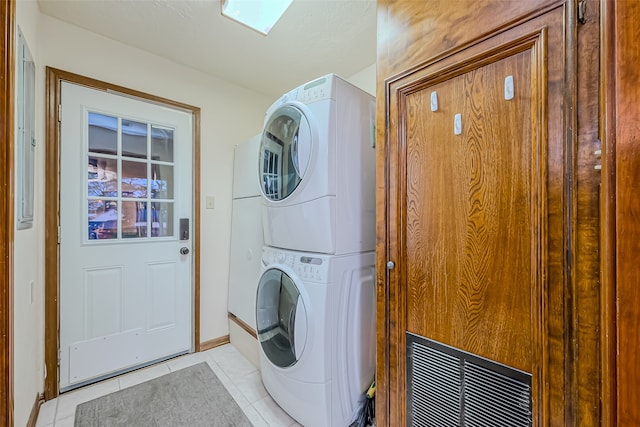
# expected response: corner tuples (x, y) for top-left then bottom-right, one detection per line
(75, 362), (252, 427)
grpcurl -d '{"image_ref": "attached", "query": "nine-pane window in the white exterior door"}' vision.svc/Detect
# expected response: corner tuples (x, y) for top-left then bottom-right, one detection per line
(87, 112), (175, 240)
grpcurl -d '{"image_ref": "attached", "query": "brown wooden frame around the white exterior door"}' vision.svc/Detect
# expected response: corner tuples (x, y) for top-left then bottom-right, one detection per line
(44, 67), (200, 400)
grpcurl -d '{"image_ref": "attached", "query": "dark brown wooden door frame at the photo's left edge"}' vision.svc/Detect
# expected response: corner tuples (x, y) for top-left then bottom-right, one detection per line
(0, 0), (16, 426)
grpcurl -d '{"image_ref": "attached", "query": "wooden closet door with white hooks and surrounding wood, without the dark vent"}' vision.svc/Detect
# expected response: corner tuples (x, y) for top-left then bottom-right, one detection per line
(378, 1), (597, 426)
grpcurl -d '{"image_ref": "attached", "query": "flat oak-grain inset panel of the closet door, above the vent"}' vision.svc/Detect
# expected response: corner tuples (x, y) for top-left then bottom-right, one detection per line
(403, 52), (541, 372)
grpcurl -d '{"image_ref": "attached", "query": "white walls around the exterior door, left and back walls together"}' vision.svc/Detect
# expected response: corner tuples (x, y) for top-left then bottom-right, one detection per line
(14, 0), (273, 426)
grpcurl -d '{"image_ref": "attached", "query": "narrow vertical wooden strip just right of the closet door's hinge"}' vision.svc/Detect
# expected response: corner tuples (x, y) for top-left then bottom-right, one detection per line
(571, 0), (601, 427)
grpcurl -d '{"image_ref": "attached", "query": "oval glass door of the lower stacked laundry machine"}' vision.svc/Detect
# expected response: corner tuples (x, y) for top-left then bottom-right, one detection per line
(256, 268), (307, 368)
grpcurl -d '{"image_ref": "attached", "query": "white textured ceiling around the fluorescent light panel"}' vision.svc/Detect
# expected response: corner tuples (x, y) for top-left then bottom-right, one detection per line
(38, 0), (376, 97)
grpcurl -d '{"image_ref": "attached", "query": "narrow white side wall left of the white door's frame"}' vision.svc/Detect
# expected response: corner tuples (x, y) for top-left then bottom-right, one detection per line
(13, 1), (45, 426)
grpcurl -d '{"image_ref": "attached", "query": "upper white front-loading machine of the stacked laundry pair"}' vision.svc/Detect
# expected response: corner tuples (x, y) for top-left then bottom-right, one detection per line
(258, 74), (375, 255)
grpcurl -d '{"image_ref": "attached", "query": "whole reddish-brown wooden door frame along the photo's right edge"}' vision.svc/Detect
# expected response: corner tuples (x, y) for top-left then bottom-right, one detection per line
(600, 0), (640, 427)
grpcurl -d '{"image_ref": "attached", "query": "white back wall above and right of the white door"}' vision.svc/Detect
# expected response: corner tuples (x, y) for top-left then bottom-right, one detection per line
(40, 11), (272, 342)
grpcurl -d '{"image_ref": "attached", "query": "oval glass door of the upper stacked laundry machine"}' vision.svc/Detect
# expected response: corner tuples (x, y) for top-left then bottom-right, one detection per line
(259, 105), (311, 201)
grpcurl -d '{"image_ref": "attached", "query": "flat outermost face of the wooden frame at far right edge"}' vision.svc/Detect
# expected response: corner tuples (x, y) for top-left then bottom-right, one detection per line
(612, 1), (640, 427)
